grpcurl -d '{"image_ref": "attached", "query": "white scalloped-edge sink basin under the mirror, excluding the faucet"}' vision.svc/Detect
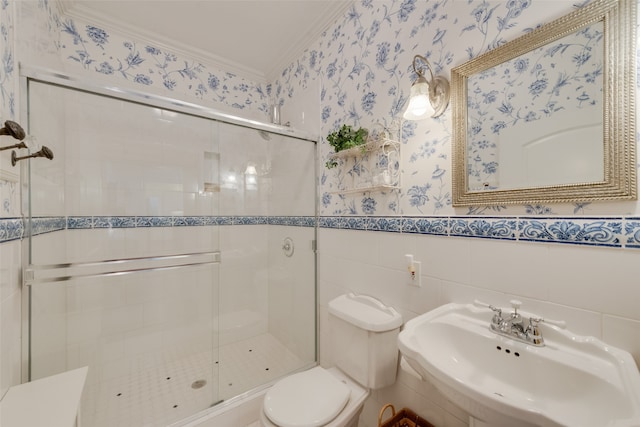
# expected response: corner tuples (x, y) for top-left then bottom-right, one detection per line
(398, 303), (640, 427)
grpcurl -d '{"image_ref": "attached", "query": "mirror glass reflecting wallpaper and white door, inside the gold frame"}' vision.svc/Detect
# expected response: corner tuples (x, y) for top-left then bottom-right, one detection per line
(467, 22), (604, 191)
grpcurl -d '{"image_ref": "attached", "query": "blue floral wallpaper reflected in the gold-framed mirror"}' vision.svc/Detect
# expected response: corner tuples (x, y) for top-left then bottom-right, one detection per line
(467, 23), (604, 190)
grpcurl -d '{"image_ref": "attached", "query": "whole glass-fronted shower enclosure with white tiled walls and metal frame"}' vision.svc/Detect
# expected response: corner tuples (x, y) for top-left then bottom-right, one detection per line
(22, 70), (316, 427)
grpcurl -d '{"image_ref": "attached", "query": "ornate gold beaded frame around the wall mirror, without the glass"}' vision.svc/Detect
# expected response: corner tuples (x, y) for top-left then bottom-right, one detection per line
(451, 0), (637, 206)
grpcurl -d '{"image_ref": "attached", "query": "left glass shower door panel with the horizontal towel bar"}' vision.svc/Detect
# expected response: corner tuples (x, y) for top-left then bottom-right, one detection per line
(25, 81), (221, 427)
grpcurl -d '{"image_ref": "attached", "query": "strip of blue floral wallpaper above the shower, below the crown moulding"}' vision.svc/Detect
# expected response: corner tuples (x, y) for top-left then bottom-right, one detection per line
(16, 0), (276, 121)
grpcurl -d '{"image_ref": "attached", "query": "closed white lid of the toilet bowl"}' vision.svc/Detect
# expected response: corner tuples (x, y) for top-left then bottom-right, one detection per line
(264, 366), (351, 427)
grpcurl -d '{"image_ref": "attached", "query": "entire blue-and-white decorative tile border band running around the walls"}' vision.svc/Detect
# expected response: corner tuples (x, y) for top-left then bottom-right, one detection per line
(0, 216), (640, 249)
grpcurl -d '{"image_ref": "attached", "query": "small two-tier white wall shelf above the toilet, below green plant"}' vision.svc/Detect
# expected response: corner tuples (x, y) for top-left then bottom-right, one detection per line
(329, 136), (400, 194)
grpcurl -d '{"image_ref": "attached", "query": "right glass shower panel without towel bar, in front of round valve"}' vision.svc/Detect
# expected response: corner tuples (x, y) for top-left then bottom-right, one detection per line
(220, 123), (316, 399)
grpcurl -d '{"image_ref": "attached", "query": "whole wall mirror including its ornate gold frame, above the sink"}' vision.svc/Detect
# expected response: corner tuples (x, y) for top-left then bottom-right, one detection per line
(451, 0), (637, 206)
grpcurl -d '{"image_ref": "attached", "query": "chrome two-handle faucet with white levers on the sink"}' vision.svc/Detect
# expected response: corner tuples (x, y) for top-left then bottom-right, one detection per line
(476, 300), (565, 347)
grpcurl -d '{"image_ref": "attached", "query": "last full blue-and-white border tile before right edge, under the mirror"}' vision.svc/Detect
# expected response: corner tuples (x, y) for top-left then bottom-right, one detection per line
(518, 218), (623, 247)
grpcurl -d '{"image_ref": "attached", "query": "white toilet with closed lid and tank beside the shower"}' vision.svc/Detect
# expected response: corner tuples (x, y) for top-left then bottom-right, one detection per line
(260, 293), (402, 427)
